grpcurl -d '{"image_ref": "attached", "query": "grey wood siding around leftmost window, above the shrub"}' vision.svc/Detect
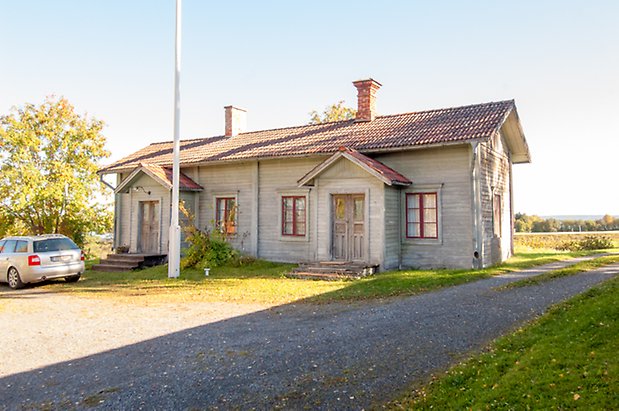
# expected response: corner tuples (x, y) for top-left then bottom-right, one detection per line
(199, 162), (255, 255)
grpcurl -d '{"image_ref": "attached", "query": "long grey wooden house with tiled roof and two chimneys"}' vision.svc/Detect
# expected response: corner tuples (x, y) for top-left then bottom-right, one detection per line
(100, 79), (530, 270)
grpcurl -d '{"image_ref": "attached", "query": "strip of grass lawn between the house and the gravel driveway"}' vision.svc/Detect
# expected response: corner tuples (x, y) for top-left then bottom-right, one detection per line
(37, 250), (612, 304)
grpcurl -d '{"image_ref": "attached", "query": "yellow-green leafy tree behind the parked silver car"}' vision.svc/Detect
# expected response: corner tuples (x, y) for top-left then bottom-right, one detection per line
(0, 97), (112, 244)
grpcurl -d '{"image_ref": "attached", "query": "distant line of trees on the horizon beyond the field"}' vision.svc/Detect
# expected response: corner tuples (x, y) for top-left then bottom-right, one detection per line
(514, 213), (619, 233)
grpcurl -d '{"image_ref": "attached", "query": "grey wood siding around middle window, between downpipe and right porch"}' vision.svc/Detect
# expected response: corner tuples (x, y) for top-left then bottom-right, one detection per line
(258, 158), (324, 262)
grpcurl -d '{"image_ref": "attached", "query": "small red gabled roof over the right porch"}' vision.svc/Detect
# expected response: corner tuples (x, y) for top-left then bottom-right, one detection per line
(298, 147), (413, 187)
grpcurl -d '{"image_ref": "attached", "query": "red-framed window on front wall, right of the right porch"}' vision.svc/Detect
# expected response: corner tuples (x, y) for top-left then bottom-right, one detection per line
(406, 193), (438, 238)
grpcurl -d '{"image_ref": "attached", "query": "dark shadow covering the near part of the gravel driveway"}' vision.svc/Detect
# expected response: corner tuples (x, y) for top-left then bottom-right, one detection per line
(0, 262), (616, 409)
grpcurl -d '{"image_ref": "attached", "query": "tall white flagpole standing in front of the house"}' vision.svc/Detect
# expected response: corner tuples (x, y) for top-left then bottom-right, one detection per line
(168, 0), (182, 278)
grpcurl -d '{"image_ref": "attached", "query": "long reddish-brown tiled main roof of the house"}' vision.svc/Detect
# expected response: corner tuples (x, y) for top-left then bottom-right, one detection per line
(100, 100), (515, 173)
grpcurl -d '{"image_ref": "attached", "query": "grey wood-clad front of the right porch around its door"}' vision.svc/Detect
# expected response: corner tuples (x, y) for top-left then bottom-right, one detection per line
(316, 159), (385, 268)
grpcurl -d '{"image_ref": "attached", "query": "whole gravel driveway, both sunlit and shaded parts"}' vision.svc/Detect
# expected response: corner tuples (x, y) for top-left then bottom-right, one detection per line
(0, 260), (619, 410)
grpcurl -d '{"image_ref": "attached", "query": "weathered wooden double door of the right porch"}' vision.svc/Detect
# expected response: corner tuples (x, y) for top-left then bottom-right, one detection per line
(331, 194), (366, 261)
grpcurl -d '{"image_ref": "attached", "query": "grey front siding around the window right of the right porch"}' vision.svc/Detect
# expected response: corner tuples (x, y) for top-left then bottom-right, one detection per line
(376, 145), (473, 268)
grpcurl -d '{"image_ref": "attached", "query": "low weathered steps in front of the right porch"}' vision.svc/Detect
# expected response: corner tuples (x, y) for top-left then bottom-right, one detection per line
(286, 261), (378, 281)
